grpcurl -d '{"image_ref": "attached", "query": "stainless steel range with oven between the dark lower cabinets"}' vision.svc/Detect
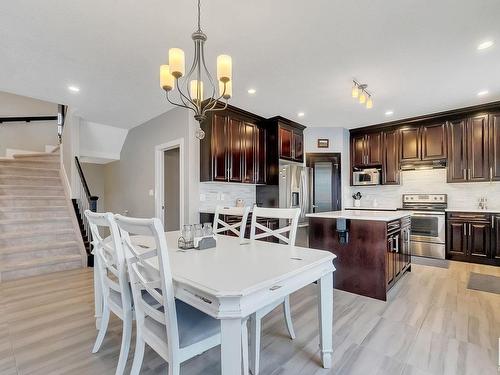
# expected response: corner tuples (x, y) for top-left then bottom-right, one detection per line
(403, 194), (448, 259)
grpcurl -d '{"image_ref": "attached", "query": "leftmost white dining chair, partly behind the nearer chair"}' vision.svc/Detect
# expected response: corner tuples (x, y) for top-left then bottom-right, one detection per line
(85, 210), (134, 375)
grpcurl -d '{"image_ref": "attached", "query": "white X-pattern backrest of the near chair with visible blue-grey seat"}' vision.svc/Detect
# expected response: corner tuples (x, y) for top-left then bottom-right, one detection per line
(115, 215), (179, 358)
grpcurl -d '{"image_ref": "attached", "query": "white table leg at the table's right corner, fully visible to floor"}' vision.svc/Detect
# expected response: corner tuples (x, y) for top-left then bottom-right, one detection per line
(318, 272), (333, 368)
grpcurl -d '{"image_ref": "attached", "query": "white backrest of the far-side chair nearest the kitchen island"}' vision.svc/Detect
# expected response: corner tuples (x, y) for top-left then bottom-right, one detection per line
(250, 206), (300, 246)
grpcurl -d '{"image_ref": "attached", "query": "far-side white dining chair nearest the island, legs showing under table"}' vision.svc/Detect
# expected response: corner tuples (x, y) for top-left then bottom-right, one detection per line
(250, 207), (300, 375)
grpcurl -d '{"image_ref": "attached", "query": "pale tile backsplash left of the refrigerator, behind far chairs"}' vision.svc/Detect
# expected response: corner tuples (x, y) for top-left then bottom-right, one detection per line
(200, 182), (256, 211)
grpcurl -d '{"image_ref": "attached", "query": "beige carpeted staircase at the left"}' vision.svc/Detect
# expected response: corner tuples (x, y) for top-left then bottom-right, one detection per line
(0, 150), (87, 282)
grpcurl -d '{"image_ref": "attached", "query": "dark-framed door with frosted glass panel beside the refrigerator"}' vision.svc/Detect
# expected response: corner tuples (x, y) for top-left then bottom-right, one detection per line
(306, 153), (342, 212)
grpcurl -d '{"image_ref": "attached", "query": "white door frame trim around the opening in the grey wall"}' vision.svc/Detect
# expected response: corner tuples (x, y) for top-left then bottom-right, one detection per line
(155, 138), (185, 227)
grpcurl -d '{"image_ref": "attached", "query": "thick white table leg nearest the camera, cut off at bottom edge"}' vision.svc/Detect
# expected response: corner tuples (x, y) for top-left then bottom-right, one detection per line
(220, 319), (242, 375)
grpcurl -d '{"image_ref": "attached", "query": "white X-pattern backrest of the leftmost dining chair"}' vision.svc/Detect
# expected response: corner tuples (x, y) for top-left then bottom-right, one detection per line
(85, 210), (132, 311)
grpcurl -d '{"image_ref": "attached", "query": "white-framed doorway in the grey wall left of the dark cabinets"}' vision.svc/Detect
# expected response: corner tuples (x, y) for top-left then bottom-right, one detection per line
(155, 139), (184, 232)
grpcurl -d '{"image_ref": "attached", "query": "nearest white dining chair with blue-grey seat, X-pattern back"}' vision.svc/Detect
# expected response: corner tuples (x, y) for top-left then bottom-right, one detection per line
(115, 215), (248, 375)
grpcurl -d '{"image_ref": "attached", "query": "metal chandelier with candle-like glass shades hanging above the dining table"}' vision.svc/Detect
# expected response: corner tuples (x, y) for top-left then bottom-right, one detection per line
(160, 0), (233, 139)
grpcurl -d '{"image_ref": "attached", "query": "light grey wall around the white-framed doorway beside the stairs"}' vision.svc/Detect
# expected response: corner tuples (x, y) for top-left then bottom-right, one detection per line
(104, 108), (200, 223)
